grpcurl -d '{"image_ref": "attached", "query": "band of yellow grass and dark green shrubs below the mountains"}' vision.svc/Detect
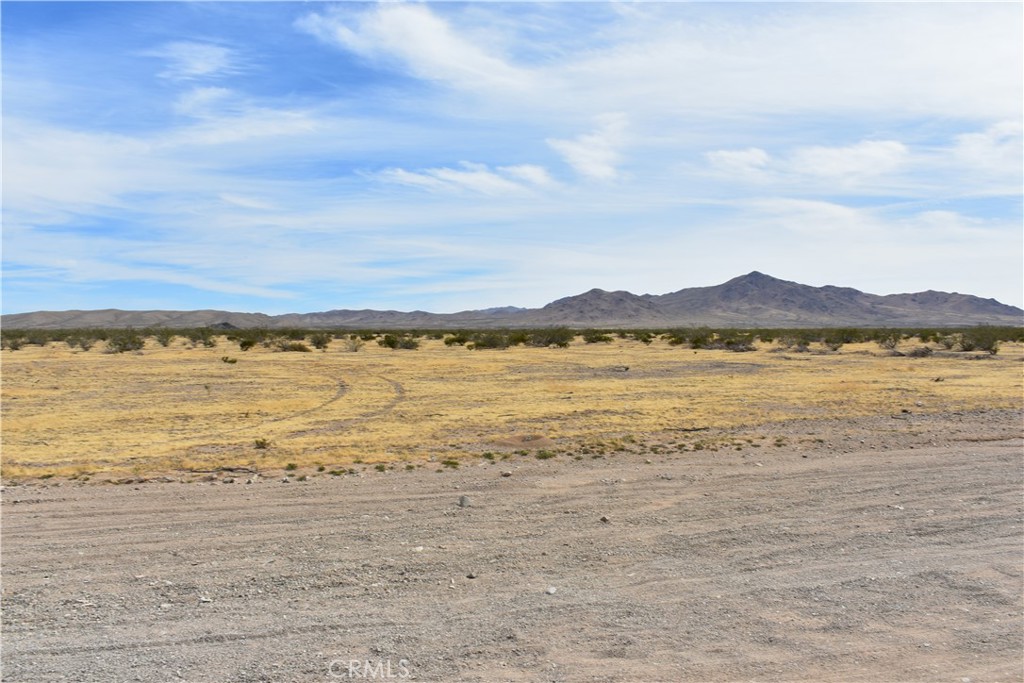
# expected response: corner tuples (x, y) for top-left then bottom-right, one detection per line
(0, 327), (1024, 479)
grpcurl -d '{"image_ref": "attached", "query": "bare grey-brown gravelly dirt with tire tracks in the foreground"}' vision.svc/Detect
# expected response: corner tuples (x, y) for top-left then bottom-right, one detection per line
(2, 411), (1024, 683)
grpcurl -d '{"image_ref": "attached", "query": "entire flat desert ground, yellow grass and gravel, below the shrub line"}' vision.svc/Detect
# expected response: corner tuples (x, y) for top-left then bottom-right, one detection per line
(2, 338), (1024, 683)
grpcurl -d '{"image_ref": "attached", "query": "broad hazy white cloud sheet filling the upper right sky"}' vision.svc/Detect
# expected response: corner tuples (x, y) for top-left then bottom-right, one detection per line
(544, 3), (1024, 120)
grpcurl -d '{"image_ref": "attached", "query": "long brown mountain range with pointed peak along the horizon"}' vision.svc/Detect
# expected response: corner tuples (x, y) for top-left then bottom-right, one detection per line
(0, 271), (1024, 329)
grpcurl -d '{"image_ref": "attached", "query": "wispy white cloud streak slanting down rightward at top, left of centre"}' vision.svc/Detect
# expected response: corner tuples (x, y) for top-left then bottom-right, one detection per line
(296, 4), (529, 89)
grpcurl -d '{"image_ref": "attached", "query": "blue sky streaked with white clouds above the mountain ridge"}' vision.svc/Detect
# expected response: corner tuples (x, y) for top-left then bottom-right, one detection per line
(0, 2), (1024, 313)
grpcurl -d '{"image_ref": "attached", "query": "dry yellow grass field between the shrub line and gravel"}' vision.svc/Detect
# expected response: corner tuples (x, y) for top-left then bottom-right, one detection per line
(2, 339), (1024, 478)
